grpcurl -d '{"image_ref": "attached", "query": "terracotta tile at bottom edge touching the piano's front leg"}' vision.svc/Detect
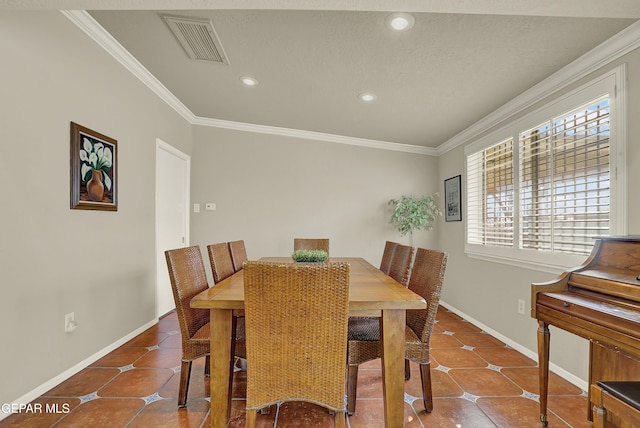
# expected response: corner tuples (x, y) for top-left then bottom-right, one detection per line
(476, 397), (569, 428)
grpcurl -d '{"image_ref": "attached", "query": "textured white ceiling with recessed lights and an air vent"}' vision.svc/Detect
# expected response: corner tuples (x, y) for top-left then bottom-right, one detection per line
(2, 0), (640, 147)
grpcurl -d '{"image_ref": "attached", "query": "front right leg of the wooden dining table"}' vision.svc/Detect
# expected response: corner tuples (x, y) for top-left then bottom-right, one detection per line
(381, 309), (406, 428)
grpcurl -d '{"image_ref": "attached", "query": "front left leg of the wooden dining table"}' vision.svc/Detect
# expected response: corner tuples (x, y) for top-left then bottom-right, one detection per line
(209, 309), (235, 428)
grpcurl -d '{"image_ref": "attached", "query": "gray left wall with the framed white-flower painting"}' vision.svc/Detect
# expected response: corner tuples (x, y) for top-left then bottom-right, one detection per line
(0, 11), (192, 403)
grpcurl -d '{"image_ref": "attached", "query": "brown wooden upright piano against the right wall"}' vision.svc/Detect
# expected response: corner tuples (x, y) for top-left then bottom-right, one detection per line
(531, 236), (640, 426)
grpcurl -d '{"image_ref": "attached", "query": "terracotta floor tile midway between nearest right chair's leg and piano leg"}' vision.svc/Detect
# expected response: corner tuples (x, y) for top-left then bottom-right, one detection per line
(449, 369), (523, 396)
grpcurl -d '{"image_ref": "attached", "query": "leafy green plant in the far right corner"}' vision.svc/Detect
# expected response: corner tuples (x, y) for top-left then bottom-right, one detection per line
(389, 193), (442, 246)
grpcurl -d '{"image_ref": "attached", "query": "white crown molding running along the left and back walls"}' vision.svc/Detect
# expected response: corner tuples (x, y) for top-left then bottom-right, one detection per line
(60, 10), (437, 156)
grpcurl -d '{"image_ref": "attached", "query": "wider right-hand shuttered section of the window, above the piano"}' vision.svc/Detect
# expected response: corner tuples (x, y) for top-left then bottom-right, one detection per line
(520, 97), (610, 255)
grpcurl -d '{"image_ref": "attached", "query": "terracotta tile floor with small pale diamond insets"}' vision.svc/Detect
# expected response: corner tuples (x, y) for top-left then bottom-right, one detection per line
(0, 307), (593, 428)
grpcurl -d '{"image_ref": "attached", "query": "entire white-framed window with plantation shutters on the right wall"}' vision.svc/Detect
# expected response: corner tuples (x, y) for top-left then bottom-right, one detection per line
(465, 71), (626, 272)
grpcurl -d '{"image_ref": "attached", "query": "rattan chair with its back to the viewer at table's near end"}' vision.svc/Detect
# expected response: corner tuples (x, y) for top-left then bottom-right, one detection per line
(244, 261), (350, 427)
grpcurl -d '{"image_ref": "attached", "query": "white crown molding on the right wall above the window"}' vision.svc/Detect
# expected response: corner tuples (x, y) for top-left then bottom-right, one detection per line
(436, 22), (640, 156)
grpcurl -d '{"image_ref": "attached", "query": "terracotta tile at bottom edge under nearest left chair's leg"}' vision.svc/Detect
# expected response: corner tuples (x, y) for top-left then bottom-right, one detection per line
(128, 399), (209, 428)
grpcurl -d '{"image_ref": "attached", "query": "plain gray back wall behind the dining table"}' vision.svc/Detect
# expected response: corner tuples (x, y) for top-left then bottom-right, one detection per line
(191, 127), (438, 272)
